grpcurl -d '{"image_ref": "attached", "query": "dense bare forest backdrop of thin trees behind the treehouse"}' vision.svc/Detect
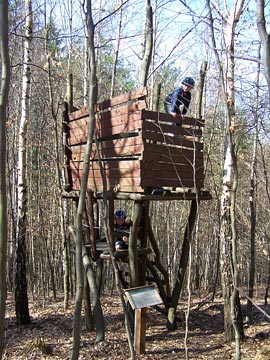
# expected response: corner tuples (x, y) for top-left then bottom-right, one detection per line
(1, 0), (270, 358)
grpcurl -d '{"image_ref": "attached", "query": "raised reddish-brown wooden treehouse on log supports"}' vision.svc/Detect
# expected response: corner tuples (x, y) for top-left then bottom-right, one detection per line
(64, 88), (211, 301)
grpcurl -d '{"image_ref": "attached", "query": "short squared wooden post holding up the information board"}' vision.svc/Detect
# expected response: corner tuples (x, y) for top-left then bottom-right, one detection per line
(134, 307), (147, 355)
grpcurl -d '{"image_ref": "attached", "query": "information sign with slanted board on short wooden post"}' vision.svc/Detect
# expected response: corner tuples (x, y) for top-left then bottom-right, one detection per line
(125, 285), (162, 355)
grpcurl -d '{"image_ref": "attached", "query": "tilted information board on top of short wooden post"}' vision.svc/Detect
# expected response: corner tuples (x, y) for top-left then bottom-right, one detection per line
(125, 285), (163, 310)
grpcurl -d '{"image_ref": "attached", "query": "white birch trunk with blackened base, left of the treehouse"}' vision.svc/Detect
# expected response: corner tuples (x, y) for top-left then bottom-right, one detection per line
(15, 0), (33, 324)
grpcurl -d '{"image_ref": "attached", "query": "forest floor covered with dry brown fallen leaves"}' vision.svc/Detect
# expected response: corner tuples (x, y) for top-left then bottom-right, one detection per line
(3, 294), (270, 360)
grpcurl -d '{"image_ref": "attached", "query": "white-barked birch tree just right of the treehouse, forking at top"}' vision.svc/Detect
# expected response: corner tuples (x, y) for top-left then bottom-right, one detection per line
(207, 0), (245, 359)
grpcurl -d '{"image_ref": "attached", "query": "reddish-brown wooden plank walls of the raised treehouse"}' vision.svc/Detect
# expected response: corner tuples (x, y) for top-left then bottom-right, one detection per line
(65, 88), (204, 193)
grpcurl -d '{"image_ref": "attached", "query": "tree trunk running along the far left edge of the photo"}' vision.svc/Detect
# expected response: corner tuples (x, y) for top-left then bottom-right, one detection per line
(0, 0), (10, 359)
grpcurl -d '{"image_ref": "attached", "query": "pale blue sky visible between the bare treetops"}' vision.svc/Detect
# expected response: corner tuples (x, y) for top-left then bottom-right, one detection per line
(38, 0), (270, 93)
